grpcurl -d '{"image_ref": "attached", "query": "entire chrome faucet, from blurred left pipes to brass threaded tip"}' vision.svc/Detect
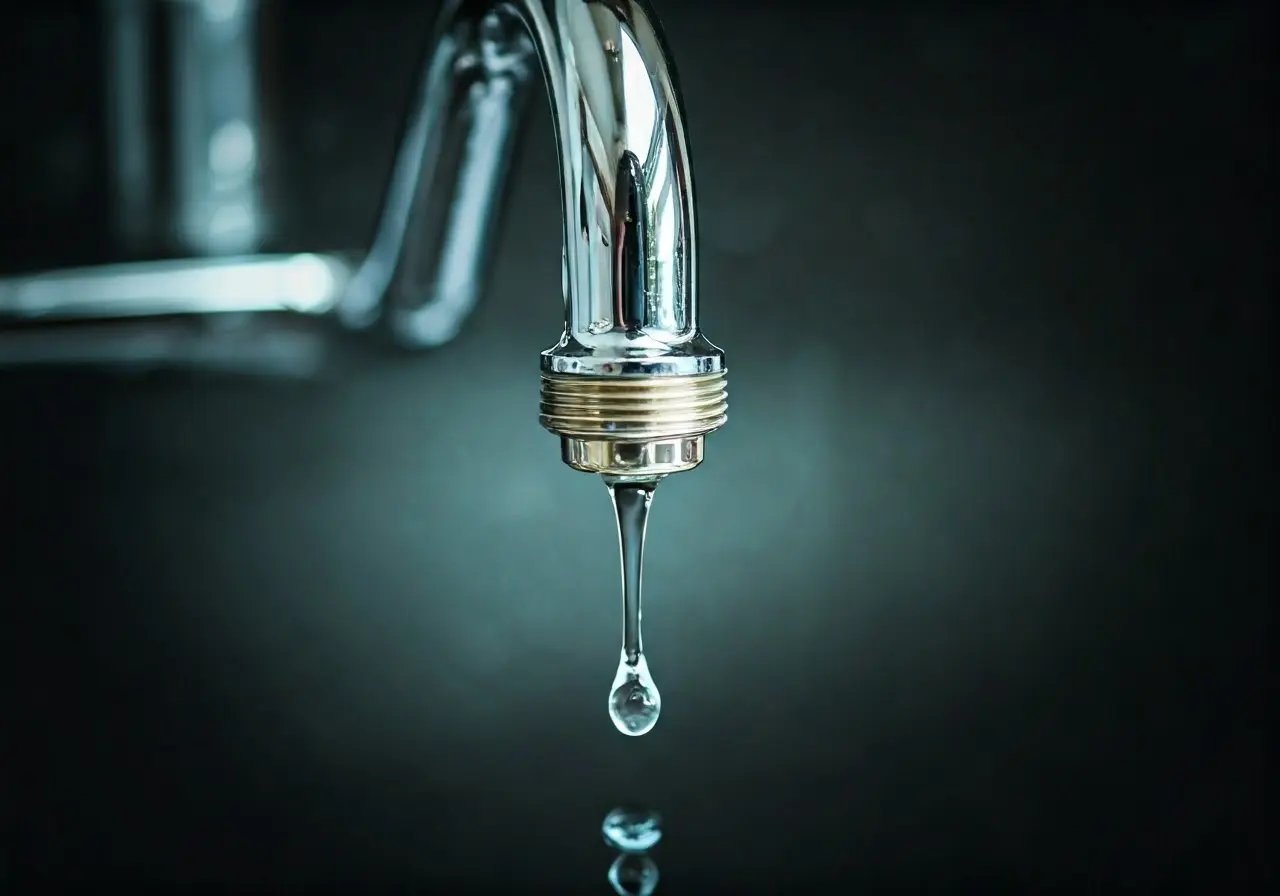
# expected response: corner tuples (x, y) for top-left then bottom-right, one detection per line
(0, 0), (727, 479)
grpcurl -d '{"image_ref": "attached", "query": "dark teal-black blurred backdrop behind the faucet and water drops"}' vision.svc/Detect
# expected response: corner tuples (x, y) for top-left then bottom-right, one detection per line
(0, 0), (1276, 895)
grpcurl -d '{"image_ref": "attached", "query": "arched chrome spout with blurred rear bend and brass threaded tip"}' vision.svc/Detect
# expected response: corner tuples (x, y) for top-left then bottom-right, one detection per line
(339, 0), (727, 480)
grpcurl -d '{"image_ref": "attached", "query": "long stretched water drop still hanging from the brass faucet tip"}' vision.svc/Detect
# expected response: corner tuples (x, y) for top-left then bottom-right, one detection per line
(605, 480), (662, 737)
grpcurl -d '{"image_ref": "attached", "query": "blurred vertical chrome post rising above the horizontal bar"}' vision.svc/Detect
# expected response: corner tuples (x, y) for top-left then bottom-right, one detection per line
(101, 0), (266, 256)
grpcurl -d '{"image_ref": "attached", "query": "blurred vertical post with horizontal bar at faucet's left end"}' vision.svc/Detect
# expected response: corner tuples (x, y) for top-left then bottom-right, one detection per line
(0, 0), (352, 374)
